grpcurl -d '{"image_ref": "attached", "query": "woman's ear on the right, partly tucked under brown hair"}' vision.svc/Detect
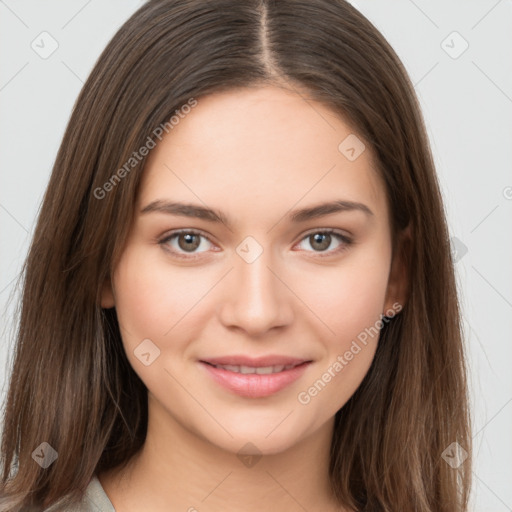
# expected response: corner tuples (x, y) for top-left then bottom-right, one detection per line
(382, 223), (412, 315)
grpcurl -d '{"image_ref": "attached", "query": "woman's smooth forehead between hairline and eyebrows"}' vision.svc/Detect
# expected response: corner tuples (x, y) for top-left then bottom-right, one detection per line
(139, 87), (387, 224)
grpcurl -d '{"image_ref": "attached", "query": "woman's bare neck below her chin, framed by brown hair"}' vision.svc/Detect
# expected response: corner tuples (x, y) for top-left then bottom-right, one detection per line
(98, 394), (341, 512)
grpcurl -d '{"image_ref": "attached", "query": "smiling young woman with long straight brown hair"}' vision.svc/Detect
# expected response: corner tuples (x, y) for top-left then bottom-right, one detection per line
(1, 0), (471, 512)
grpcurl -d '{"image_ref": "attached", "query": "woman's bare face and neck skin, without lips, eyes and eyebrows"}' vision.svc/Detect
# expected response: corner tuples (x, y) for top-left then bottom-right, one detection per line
(99, 87), (405, 512)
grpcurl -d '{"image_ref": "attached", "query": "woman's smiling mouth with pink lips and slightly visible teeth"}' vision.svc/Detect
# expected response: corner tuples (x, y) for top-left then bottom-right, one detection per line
(199, 357), (313, 398)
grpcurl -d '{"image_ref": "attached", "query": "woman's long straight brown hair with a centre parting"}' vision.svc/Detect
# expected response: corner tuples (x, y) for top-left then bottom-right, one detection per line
(0, 0), (471, 512)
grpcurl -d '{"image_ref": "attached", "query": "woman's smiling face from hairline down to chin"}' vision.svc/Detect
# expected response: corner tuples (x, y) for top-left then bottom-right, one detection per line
(102, 87), (406, 454)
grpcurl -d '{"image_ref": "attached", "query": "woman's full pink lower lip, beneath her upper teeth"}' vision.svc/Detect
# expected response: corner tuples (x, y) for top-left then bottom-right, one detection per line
(201, 361), (311, 398)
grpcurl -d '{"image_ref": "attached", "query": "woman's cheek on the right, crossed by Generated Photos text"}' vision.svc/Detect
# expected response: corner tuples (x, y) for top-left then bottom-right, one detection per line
(290, 252), (389, 410)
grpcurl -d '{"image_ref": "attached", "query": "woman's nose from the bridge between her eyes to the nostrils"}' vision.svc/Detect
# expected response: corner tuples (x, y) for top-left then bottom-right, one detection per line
(222, 237), (291, 334)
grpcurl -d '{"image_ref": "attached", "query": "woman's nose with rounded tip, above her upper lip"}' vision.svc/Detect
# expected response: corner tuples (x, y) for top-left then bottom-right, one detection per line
(219, 246), (293, 337)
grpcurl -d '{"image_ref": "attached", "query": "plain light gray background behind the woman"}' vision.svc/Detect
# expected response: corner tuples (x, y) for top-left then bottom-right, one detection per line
(0, 0), (512, 512)
